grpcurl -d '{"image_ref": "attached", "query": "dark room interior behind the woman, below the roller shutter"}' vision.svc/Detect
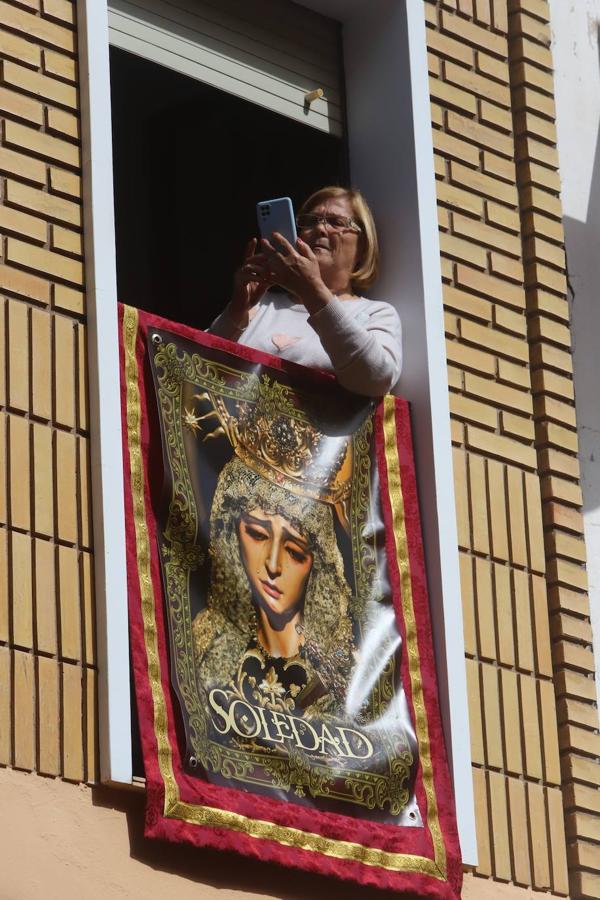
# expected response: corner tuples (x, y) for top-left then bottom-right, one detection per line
(110, 47), (347, 328)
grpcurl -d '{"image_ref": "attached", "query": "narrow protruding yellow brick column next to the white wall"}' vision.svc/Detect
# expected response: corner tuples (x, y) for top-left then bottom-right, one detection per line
(510, 0), (600, 897)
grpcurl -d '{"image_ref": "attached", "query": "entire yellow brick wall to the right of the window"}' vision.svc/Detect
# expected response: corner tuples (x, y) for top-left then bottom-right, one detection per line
(425, 0), (600, 897)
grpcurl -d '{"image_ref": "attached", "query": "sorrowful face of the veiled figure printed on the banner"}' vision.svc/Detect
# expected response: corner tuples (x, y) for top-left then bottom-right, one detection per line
(238, 507), (313, 620)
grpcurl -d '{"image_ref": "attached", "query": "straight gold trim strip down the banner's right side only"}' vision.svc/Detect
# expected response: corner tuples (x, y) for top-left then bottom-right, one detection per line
(383, 396), (446, 878)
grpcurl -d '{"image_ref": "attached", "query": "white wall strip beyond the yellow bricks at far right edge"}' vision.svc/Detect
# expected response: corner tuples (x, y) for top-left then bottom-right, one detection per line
(550, 0), (600, 708)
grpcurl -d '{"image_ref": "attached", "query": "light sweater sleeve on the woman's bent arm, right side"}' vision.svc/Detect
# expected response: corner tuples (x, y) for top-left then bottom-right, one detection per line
(308, 297), (402, 397)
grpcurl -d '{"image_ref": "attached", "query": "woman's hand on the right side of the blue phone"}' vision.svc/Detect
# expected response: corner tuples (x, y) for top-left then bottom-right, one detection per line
(260, 231), (331, 315)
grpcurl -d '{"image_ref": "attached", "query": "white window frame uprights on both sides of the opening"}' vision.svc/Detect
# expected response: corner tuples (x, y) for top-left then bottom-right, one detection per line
(78, 0), (477, 865)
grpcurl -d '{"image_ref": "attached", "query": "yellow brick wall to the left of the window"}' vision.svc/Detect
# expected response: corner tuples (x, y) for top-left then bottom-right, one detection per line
(0, 0), (96, 781)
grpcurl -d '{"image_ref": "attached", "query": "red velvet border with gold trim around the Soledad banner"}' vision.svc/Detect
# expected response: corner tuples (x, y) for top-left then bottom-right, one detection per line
(120, 307), (462, 898)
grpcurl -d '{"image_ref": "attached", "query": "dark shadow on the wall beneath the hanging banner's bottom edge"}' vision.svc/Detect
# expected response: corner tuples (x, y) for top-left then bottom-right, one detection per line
(92, 787), (408, 900)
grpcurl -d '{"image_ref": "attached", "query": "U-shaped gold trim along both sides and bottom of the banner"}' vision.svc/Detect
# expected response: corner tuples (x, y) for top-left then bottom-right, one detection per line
(123, 307), (445, 880)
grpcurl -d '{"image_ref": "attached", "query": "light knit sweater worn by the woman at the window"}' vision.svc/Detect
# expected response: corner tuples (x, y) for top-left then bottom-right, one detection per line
(209, 291), (402, 397)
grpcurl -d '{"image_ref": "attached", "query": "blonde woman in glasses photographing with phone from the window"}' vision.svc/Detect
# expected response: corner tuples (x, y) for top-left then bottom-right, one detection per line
(210, 187), (402, 397)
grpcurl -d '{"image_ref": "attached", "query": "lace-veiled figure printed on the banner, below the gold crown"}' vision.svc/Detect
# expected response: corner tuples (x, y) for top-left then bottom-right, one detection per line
(193, 457), (354, 713)
